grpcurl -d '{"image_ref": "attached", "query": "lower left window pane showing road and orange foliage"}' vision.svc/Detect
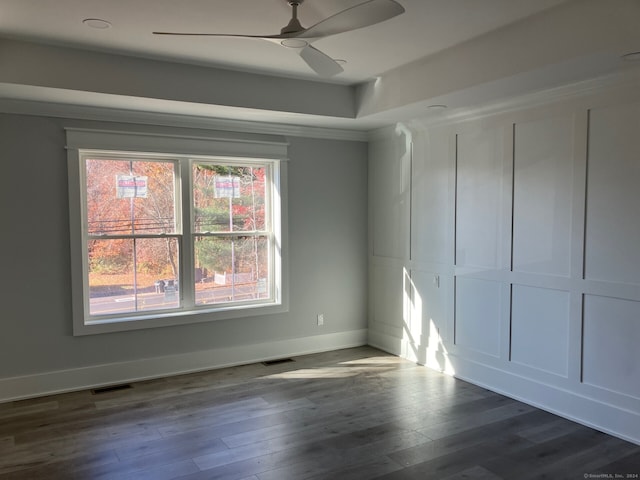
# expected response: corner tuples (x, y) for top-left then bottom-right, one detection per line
(88, 237), (180, 315)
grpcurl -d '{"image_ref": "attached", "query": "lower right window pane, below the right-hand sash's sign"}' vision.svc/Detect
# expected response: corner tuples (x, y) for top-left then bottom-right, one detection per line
(195, 236), (271, 305)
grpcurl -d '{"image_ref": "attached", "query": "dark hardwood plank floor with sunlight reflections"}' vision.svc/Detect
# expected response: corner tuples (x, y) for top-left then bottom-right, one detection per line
(0, 347), (640, 480)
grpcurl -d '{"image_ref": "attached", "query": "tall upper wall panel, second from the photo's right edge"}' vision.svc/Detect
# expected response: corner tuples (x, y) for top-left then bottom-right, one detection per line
(513, 116), (573, 277)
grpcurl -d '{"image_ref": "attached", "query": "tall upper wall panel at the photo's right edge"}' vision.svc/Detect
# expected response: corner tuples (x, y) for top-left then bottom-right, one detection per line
(585, 103), (640, 284)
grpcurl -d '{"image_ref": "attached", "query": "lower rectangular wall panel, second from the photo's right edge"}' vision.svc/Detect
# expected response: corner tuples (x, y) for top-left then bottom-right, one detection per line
(511, 285), (569, 377)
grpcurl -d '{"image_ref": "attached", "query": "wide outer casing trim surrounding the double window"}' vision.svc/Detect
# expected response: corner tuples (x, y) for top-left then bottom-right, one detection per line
(65, 128), (289, 336)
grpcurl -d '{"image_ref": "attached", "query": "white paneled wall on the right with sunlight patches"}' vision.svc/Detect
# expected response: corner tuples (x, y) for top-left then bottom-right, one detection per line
(369, 81), (640, 443)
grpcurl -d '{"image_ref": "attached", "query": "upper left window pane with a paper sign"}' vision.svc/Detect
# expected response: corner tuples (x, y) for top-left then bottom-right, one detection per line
(86, 159), (176, 235)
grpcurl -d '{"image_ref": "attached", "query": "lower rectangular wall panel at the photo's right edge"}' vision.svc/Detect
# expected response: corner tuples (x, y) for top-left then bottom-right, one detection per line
(582, 295), (640, 399)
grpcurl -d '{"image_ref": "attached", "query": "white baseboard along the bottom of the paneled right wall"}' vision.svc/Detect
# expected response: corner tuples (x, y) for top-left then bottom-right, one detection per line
(369, 331), (640, 445)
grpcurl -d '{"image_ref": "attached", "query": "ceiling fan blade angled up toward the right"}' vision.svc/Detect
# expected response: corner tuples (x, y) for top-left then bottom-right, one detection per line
(297, 0), (405, 38)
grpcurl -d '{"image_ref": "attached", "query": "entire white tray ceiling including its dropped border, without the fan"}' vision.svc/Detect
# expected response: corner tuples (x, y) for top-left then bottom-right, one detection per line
(0, 0), (640, 131)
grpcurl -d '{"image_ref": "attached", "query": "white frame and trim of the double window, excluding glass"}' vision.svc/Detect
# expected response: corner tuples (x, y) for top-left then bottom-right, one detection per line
(66, 128), (289, 335)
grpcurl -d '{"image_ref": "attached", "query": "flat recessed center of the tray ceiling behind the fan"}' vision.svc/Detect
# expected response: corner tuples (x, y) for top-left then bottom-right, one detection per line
(0, 0), (565, 84)
